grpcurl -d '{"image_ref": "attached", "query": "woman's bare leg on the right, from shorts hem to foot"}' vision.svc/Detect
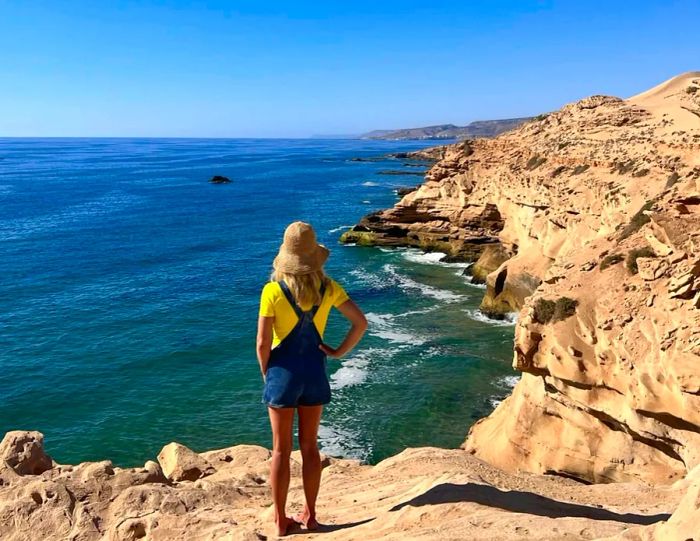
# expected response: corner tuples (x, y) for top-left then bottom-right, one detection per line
(294, 406), (323, 530)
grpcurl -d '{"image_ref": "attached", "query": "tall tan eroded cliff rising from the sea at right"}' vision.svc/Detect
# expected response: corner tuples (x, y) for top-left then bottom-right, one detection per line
(343, 72), (700, 483)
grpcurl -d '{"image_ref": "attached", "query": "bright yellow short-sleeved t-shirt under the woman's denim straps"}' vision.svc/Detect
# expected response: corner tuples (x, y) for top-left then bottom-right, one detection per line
(260, 279), (350, 347)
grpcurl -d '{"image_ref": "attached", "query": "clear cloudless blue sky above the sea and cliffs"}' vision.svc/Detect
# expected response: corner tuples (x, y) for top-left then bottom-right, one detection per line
(0, 0), (700, 137)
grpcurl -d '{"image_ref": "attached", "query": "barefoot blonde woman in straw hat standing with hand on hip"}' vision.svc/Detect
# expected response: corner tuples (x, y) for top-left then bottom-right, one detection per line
(257, 222), (367, 535)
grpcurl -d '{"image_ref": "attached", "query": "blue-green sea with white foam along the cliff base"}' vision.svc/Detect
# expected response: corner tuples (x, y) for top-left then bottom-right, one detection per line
(0, 139), (515, 465)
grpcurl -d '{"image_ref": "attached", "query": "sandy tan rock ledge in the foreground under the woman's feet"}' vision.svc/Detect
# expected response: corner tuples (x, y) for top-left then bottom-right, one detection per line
(0, 433), (698, 541)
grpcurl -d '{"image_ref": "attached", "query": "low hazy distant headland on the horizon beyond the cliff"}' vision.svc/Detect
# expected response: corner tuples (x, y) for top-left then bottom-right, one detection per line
(360, 117), (532, 141)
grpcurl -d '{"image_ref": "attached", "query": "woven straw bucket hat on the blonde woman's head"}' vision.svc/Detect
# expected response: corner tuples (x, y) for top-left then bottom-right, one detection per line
(272, 222), (329, 274)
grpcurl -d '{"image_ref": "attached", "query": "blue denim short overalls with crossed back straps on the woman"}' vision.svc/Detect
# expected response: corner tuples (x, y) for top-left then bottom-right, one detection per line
(263, 281), (331, 408)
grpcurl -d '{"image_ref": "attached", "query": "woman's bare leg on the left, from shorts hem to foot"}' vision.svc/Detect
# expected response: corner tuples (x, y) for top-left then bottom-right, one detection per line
(267, 408), (294, 535)
